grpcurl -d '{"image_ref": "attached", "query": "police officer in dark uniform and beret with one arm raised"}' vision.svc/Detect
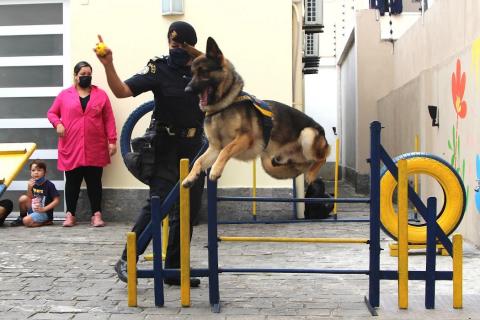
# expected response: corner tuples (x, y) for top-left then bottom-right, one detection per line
(97, 21), (204, 287)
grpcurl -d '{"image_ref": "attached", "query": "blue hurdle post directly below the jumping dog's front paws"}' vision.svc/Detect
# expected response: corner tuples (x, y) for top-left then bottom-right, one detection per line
(207, 175), (220, 313)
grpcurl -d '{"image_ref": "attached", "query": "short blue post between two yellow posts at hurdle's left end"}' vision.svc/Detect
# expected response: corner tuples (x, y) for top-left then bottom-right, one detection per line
(150, 196), (164, 307)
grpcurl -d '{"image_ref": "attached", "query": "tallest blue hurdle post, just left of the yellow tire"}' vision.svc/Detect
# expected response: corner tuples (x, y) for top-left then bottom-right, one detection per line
(368, 121), (382, 308)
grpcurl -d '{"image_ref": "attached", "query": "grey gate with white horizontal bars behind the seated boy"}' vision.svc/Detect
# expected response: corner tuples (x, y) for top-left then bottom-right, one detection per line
(0, 0), (71, 218)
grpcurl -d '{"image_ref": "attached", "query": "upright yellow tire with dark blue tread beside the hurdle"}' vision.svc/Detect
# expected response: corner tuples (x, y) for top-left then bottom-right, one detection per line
(380, 152), (466, 244)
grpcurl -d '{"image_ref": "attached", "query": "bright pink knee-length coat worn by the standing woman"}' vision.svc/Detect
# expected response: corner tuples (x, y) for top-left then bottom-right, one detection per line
(47, 86), (117, 171)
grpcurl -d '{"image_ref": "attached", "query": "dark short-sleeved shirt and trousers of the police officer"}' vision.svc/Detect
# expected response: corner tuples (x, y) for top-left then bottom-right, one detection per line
(122, 57), (204, 268)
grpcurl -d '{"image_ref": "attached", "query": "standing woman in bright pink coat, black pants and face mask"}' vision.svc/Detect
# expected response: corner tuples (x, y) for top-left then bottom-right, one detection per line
(47, 61), (117, 227)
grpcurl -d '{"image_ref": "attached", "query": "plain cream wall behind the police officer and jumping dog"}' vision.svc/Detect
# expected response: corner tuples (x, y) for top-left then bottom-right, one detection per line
(70, 0), (292, 188)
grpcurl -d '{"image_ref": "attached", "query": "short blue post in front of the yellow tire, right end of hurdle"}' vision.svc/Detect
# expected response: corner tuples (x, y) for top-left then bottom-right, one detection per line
(425, 197), (437, 309)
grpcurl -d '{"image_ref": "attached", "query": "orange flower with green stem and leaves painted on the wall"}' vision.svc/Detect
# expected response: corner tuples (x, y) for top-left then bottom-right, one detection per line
(448, 59), (469, 203)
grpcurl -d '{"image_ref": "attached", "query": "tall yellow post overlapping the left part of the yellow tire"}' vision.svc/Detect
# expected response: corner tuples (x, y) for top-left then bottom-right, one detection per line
(398, 160), (408, 309)
